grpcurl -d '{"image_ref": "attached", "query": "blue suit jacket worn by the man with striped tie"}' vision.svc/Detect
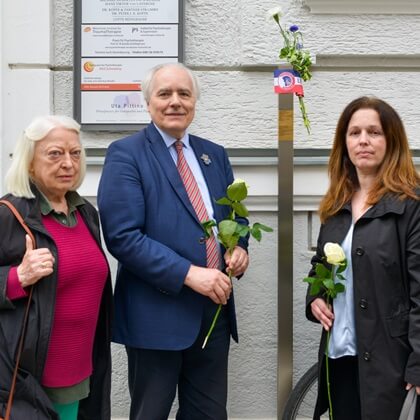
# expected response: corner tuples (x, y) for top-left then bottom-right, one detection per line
(98, 124), (247, 350)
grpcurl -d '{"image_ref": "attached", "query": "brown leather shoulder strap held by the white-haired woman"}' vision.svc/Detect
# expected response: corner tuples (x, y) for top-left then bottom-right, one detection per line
(0, 200), (36, 420)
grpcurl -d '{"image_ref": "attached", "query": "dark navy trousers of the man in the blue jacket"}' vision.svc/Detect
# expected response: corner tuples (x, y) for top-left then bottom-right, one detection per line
(126, 304), (230, 420)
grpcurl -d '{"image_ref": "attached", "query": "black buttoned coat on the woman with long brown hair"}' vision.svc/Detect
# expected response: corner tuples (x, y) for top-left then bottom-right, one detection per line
(306, 196), (420, 420)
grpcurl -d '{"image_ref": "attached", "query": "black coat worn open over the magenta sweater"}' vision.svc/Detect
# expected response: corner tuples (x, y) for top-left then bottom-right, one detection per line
(0, 193), (112, 420)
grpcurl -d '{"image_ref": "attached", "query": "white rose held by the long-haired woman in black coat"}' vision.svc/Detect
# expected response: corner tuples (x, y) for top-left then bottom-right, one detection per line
(303, 242), (347, 420)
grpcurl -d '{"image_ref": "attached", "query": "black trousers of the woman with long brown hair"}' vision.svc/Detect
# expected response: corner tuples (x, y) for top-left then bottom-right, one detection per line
(328, 356), (362, 420)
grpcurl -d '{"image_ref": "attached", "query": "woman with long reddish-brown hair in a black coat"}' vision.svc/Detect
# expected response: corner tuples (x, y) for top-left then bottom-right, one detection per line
(306, 97), (420, 420)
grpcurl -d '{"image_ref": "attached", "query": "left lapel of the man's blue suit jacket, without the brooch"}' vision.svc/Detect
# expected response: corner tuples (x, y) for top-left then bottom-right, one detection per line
(146, 124), (200, 224)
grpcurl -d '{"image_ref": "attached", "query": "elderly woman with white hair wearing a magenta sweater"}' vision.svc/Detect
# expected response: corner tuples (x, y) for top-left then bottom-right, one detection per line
(0, 116), (112, 420)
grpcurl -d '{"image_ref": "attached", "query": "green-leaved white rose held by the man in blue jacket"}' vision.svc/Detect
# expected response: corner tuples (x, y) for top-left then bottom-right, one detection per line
(201, 178), (273, 349)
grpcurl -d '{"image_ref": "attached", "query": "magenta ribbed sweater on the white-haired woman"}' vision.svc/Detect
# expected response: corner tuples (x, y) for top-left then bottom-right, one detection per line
(37, 212), (108, 387)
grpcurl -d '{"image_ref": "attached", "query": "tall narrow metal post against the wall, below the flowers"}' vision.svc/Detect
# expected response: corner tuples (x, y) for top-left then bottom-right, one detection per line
(277, 94), (293, 419)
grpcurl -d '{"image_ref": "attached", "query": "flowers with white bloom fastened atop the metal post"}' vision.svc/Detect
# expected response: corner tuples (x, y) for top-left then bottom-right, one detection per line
(267, 7), (312, 134)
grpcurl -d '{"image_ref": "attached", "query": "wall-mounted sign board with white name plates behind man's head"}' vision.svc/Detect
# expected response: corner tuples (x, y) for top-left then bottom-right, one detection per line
(73, 0), (183, 131)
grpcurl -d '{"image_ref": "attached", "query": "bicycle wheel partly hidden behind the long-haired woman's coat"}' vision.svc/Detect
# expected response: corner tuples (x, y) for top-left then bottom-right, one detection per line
(282, 363), (328, 420)
